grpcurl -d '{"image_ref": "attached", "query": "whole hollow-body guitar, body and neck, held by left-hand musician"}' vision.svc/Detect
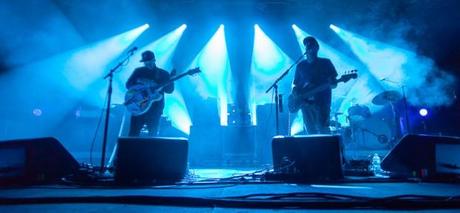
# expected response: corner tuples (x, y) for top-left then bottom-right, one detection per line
(124, 68), (201, 116)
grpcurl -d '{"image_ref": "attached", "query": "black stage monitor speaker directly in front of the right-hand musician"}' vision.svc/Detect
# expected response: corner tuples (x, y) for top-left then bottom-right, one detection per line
(272, 135), (343, 181)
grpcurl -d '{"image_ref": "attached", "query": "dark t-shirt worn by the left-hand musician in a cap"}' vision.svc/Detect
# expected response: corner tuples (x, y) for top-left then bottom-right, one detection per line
(126, 67), (174, 110)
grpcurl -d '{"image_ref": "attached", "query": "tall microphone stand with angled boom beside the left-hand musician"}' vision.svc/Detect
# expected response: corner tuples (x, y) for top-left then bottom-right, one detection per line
(99, 51), (134, 174)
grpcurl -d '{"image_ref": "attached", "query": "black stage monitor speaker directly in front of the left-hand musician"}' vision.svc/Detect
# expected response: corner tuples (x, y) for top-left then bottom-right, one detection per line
(115, 137), (188, 184)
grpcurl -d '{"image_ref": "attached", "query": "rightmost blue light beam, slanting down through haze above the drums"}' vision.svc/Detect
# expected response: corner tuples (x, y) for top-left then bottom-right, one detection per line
(330, 24), (455, 106)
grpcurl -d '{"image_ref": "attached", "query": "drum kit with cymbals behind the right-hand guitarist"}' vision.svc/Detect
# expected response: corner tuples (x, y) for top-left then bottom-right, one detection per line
(330, 91), (402, 150)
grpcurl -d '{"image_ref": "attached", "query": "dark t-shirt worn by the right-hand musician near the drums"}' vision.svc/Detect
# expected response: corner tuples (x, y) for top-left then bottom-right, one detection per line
(294, 58), (337, 104)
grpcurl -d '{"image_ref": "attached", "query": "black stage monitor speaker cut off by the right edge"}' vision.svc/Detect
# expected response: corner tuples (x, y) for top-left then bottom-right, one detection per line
(381, 135), (460, 177)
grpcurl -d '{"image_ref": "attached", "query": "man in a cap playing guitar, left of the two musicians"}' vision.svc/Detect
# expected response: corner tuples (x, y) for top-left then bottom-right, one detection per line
(126, 51), (175, 136)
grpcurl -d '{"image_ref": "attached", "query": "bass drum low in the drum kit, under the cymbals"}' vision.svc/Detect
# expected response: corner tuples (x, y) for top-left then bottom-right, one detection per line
(350, 117), (391, 150)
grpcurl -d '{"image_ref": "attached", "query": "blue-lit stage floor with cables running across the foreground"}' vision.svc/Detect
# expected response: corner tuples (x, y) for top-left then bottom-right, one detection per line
(0, 168), (460, 212)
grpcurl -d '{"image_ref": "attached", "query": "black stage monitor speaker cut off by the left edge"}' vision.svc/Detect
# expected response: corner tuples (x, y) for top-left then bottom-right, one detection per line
(0, 137), (79, 184)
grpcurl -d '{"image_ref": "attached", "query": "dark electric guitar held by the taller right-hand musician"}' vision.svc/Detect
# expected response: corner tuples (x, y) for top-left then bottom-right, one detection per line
(288, 70), (358, 113)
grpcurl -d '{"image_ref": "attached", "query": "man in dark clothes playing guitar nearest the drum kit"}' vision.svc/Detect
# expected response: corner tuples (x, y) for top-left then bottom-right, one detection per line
(292, 36), (337, 134)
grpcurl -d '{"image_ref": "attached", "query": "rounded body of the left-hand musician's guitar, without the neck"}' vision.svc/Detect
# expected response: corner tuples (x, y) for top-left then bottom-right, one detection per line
(125, 84), (163, 116)
